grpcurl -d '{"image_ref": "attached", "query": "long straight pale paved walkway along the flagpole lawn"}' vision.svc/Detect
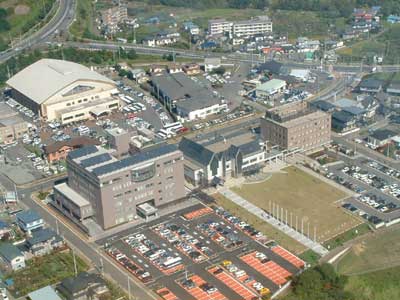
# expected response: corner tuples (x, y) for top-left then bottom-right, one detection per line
(219, 187), (329, 256)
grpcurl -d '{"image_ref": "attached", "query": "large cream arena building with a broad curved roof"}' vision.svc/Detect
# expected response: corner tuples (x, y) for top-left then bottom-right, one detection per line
(7, 59), (120, 124)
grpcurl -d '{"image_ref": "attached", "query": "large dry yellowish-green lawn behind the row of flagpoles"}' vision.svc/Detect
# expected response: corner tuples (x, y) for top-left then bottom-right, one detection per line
(232, 167), (361, 242)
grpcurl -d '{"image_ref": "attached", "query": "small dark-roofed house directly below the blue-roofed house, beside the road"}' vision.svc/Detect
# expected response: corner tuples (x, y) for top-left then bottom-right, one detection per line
(26, 228), (64, 256)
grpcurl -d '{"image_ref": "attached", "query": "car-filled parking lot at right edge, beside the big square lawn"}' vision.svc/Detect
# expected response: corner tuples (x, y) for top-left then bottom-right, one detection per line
(327, 156), (400, 225)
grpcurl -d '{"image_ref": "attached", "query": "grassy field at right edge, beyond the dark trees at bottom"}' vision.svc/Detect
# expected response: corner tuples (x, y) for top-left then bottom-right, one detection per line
(337, 225), (400, 275)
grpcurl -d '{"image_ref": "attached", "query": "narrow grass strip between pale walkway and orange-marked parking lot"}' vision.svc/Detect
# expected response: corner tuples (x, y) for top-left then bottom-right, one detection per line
(213, 194), (306, 254)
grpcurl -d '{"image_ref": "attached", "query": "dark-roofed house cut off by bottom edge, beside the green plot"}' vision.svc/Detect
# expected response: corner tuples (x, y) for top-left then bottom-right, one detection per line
(58, 272), (109, 300)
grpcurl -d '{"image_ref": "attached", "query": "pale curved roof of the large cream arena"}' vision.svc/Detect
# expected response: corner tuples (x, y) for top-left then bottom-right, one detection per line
(7, 58), (114, 104)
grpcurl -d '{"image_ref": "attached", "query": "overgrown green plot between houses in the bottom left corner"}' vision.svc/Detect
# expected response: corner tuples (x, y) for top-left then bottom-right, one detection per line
(6, 252), (88, 297)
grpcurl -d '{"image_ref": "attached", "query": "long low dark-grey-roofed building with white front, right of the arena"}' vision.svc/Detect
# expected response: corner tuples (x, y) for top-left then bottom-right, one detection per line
(152, 72), (227, 121)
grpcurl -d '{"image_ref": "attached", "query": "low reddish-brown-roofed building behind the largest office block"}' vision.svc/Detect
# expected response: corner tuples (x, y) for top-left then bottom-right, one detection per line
(44, 136), (100, 163)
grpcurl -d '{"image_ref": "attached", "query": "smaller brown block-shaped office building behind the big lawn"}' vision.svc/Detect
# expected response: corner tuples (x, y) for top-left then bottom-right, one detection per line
(261, 101), (331, 151)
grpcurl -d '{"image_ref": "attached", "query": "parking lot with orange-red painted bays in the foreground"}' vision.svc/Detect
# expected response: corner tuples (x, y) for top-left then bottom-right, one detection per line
(98, 204), (304, 300)
